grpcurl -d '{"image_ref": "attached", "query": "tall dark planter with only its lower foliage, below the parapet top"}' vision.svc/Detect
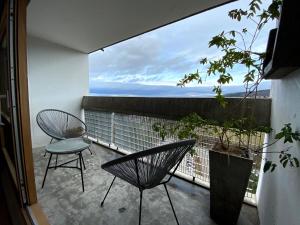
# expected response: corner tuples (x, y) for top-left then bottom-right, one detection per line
(176, 113), (300, 224)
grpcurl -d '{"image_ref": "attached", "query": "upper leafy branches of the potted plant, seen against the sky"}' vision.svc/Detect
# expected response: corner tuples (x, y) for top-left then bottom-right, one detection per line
(178, 0), (282, 107)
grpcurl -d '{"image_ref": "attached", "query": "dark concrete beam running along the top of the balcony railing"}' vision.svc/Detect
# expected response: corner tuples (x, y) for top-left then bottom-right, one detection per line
(82, 96), (271, 126)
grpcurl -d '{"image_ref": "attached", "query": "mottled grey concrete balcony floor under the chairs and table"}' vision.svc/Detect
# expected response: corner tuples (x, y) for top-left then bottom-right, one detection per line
(33, 145), (259, 225)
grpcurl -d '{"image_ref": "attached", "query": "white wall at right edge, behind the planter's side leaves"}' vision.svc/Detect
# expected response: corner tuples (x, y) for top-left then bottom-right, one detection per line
(258, 70), (300, 225)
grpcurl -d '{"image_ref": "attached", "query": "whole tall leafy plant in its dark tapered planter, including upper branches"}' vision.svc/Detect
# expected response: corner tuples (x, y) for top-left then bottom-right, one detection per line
(177, 0), (300, 224)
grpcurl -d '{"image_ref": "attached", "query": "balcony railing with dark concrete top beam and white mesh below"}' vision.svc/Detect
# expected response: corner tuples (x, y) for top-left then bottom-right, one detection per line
(82, 96), (271, 205)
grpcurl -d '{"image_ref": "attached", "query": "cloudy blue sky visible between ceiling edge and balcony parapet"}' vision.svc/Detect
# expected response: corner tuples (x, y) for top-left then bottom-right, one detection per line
(89, 0), (275, 96)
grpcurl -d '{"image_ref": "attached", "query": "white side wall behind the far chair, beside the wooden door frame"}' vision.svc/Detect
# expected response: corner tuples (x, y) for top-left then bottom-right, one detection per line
(28, 36), (89, 147)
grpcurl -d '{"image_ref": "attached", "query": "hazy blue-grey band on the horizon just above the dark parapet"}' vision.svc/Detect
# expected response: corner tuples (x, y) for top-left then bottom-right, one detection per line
(90, 82), (270, 97)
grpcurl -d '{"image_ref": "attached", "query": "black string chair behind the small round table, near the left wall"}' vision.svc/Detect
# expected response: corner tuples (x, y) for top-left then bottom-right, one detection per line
(36, 109), (92, 165)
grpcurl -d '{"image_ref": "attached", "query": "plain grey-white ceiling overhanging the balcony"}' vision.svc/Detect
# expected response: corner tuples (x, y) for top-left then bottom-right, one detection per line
(27, 0), (232, 53)
